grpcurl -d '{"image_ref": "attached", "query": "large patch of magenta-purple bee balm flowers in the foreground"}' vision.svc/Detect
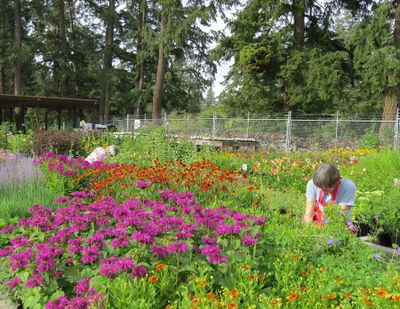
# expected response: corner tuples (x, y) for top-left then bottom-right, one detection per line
(0, 189), (265, 308)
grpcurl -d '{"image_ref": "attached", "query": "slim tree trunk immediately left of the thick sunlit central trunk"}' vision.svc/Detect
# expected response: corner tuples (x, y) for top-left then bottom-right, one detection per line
(135, 0), (147, 117)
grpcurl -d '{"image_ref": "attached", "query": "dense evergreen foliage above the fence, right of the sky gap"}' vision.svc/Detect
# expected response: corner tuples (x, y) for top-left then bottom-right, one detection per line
(217, 0), (400, 114)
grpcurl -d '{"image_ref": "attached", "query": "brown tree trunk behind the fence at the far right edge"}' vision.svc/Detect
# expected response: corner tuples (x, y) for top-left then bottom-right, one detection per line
(379, 0), (400, 141)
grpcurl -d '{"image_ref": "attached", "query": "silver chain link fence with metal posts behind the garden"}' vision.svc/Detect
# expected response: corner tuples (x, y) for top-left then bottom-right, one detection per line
(112, 110), (400, 151)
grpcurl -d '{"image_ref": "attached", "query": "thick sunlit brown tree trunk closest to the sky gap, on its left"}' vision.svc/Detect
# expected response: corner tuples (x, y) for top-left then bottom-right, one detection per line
(152, 5), (168, 125)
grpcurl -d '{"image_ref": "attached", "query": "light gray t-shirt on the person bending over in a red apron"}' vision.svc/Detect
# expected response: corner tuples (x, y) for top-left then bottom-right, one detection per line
(306, 177), (356, 206)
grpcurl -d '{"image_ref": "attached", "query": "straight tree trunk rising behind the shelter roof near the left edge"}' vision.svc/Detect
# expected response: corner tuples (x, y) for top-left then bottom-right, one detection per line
(14, 0), (24, 132)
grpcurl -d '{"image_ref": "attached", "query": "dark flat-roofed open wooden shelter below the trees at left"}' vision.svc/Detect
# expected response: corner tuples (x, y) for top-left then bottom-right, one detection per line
(0, 94), (98, 132)
